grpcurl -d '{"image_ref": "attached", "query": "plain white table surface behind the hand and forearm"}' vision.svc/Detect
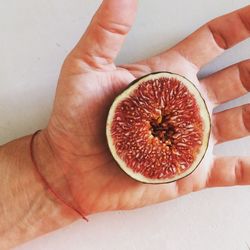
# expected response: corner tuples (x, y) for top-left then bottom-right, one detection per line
(0, 0), (250, 250)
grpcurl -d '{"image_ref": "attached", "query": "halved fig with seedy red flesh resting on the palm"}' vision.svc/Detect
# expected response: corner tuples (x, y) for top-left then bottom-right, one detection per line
(106, 72), (211, 183)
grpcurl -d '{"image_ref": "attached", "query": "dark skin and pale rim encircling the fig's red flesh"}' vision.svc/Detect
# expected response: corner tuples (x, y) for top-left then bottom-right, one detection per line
(106, 71), (211, 184)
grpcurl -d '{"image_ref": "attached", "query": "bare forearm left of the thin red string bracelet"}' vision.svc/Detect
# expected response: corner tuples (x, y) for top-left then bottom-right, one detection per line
(0, 136), (76, 249)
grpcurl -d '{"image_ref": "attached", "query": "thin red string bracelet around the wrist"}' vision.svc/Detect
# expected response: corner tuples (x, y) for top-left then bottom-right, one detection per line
(30, 130), (88, 221)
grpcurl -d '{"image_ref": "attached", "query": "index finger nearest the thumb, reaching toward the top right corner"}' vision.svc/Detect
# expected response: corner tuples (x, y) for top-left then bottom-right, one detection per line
(167, 5), (250, 68)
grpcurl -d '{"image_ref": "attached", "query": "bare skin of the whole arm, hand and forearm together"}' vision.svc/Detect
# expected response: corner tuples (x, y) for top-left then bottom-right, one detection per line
(0, 0), (250, 249)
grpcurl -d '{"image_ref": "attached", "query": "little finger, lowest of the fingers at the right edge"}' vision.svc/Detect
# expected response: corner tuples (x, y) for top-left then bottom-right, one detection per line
(206, 157), (250, 187)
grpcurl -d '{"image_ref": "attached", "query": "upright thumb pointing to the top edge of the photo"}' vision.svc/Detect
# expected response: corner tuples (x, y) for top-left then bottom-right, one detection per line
(73, 0), (137, 67)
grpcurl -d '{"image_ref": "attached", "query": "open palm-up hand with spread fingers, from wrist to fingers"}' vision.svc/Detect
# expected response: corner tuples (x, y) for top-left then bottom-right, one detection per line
(37, 0), (250, 214)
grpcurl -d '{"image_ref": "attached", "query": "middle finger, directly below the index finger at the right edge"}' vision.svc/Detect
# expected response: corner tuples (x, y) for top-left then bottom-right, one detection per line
(201, 60), (250, 104)
